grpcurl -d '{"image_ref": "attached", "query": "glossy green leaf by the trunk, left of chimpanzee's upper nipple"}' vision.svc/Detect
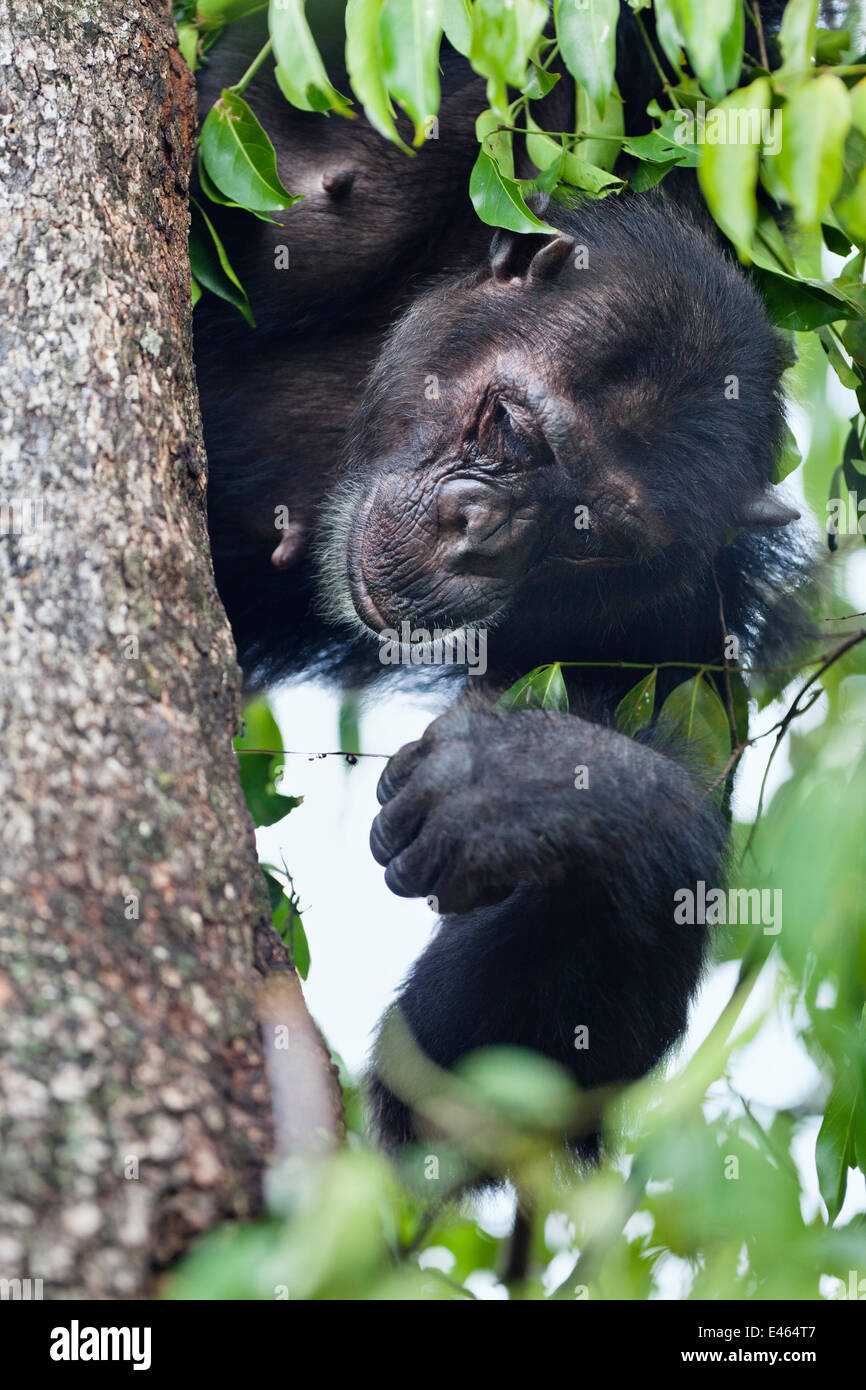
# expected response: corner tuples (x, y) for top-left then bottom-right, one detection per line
(199, 89), (297, 213)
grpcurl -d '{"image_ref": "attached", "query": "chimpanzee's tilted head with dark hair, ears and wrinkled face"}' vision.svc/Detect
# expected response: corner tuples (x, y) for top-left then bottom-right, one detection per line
(327, 193), (796, 631)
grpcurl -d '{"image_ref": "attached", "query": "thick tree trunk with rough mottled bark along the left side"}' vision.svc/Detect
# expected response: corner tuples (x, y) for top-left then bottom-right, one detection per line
(0, 0), (322, 1297)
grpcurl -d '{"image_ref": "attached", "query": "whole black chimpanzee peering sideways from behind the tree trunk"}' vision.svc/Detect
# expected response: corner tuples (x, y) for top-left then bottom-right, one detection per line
(196, 6), (803, 1150)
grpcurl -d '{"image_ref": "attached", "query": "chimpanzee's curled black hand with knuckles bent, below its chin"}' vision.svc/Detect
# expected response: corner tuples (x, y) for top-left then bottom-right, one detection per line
(370, 706), (606, 912)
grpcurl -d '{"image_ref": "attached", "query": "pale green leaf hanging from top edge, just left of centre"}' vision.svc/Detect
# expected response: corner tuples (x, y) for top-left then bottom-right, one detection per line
(379, 0), (442, 145)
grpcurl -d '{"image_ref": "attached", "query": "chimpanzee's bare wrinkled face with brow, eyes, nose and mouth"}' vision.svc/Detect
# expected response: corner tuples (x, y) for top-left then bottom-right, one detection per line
(330, 353), (674, 631)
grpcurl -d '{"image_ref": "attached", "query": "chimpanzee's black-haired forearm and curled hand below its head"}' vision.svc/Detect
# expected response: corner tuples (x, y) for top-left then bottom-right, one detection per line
(371, 706), (726, 1145)
